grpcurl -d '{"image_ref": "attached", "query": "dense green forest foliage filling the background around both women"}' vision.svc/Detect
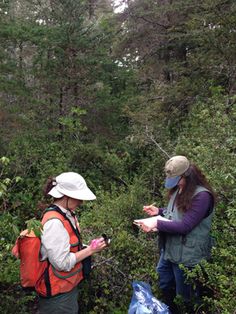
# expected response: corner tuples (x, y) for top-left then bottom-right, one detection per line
(0, 0), (236, 314)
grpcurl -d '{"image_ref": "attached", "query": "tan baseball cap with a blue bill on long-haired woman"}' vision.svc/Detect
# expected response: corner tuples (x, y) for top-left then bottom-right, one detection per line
(165, 156), (190, 189)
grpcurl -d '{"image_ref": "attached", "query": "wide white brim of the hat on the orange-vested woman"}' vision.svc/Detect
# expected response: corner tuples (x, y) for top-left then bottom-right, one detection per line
(48, 186), (96, 201)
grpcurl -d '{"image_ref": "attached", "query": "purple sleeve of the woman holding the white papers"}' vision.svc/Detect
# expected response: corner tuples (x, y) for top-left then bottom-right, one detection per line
(157, 192), (214, 234)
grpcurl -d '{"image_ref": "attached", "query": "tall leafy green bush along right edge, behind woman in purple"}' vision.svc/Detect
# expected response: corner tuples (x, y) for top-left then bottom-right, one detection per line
(173, 88), (236, 314)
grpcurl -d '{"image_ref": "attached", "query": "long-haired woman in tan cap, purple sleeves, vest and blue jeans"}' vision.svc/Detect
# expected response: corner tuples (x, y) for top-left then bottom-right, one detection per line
(141, 156), (215, 313)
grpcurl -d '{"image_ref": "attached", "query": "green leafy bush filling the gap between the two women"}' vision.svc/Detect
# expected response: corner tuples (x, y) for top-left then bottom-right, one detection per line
(79, 180), (157, 313)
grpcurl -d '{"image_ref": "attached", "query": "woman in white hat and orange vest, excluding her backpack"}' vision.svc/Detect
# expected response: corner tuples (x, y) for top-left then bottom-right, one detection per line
(36, 172), (106, 314)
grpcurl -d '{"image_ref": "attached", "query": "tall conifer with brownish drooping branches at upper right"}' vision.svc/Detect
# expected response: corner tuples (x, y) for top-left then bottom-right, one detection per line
(113, 0), (236, 140)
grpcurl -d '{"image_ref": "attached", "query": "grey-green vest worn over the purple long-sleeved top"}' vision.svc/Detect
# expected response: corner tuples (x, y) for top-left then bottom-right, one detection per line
(164, 186), (214, 267)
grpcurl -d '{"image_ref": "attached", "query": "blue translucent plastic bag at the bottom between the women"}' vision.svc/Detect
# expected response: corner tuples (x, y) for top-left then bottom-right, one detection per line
(128, 281), (171, 314)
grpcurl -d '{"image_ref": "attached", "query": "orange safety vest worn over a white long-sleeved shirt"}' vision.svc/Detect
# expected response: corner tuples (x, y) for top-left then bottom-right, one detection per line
(35, 208), (83, 297)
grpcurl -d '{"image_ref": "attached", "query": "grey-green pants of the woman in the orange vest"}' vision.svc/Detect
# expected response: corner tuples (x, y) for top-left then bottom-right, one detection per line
(39, 287), (79, 314)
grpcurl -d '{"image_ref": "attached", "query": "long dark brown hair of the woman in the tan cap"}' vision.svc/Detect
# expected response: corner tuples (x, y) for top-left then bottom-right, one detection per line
(168, 164), (216, 212)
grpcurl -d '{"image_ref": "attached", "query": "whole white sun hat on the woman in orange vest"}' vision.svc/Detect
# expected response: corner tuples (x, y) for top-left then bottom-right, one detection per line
(48, 172), (96, 201)
